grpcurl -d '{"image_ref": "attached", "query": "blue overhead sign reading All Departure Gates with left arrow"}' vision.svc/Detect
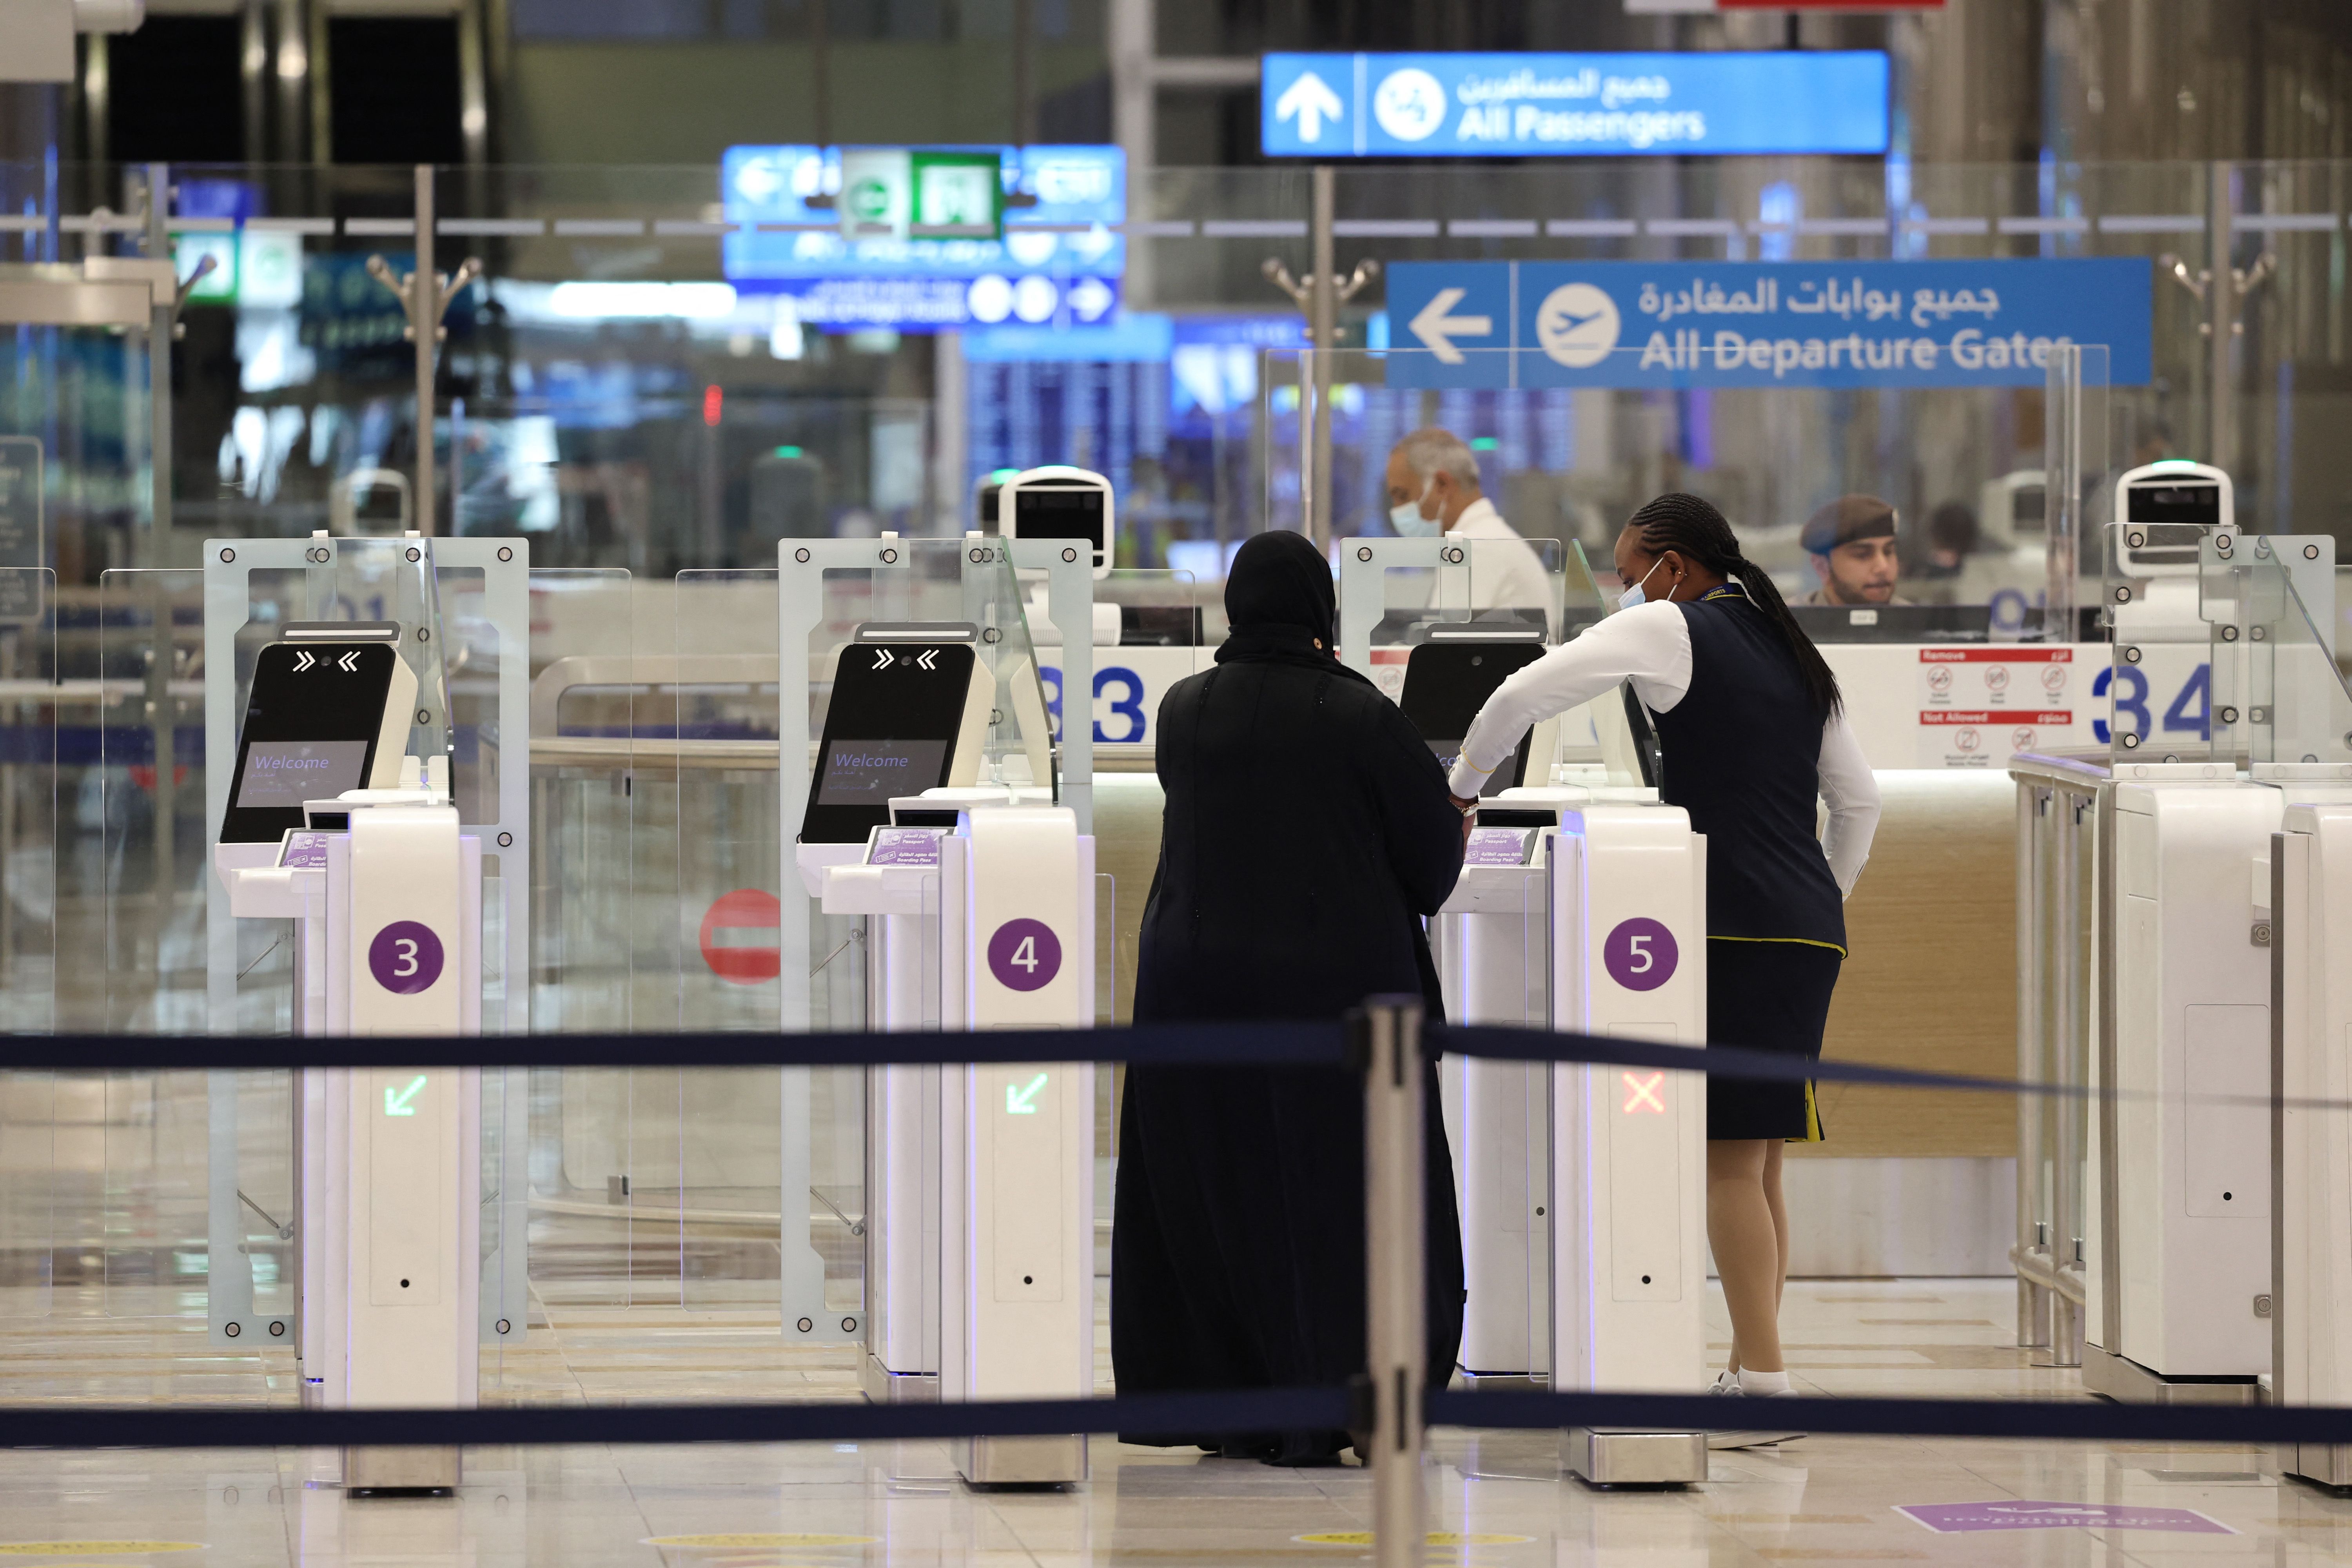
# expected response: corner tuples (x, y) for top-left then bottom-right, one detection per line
(1385, 256), (2154, 388)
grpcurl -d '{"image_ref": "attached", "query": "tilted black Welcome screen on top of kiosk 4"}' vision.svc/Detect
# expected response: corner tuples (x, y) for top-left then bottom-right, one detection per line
(800, 642), (974, 844)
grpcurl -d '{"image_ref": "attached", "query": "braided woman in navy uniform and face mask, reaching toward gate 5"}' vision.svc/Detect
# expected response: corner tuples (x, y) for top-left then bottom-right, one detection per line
(1451, 496), (1879, 1441)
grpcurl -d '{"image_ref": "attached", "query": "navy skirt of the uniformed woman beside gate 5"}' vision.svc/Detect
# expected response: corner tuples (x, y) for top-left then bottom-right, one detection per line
(1708, 936), (1844, 1143)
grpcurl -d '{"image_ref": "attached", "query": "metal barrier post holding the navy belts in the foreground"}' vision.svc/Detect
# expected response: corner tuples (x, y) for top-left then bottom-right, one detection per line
(1362, 997), (1428, 1568)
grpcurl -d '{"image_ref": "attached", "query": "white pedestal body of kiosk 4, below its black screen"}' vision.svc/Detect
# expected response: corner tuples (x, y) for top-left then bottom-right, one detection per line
(821, 808), (1094, 1486)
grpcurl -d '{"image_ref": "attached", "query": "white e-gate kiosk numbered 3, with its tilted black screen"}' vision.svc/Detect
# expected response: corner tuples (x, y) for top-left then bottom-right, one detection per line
(214, 621), (482, 1490)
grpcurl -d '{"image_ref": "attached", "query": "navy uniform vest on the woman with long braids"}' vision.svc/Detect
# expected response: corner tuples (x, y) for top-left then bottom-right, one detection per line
(1653, 585), (1846, 955)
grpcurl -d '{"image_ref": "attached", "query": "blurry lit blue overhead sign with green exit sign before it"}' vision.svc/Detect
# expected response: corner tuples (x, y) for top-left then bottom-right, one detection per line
(720, 146), (1127, 332)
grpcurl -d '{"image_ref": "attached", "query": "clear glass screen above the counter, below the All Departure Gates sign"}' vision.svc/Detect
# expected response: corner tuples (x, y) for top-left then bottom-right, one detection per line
(1298, 343), (2114, 642)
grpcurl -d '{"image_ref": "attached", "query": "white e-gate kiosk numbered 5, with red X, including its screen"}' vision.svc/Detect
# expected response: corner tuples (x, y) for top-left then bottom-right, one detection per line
(1341, 541), (1708, 1486)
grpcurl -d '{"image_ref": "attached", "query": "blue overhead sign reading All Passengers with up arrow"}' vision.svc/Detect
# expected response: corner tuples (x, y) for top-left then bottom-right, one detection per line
(1258, 49), (1889, 158)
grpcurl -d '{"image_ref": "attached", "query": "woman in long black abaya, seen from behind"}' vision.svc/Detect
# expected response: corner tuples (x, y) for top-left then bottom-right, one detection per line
(1110, 534), (1463, 1465)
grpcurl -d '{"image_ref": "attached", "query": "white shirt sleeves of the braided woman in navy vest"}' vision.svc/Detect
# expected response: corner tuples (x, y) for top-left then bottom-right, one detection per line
(1451, 599), (1879, 896)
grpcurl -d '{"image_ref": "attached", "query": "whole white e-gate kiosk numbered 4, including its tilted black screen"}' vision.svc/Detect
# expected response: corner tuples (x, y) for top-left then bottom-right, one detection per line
(786, 536), (1096, 1486)
